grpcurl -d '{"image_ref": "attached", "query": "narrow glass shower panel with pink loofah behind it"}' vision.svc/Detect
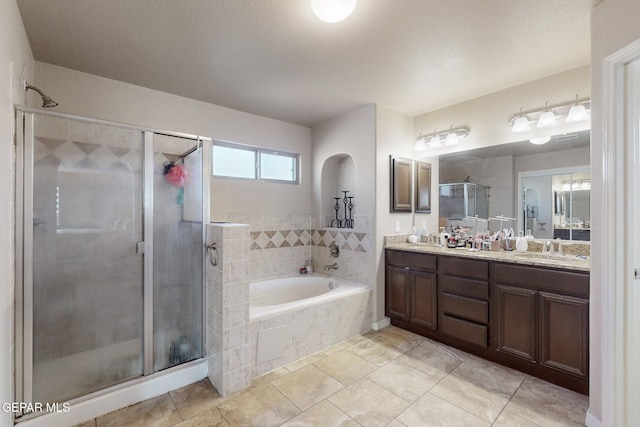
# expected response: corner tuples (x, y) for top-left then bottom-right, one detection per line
(153, 134), (204, 371)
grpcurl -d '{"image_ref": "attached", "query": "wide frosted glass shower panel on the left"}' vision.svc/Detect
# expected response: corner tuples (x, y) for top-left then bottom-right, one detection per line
(23, 113), (143, 402)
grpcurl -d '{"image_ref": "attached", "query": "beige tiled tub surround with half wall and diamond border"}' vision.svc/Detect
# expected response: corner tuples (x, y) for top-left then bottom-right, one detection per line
(206, 215), (373, 395)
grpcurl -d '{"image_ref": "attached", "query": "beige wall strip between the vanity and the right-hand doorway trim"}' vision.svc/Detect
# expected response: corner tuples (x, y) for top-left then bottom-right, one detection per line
(589, 0), (640, 425)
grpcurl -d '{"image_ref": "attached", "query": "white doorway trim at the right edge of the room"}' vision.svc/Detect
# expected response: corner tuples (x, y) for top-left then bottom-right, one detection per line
(604, 36), (640, 425)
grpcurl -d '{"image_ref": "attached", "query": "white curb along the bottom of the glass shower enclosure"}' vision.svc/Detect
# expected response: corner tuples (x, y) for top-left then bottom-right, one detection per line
(17, 359), (207, 427)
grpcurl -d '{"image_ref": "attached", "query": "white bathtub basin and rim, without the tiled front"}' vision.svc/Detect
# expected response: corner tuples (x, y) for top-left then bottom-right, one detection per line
(249, 273), (369, 320)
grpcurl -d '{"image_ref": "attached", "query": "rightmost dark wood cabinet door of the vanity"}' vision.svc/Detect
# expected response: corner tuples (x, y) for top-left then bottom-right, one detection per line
(540, 292), (589, 378)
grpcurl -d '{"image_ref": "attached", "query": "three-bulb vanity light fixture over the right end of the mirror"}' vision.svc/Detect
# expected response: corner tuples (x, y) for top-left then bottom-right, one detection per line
(509, 95), (591, 132)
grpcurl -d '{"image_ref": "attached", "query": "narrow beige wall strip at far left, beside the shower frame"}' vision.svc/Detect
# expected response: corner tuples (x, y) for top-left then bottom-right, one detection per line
(0, 0), (33, 427)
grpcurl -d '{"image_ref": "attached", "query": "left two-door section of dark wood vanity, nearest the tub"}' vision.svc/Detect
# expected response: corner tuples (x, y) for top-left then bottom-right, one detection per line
(385, 251), (438, 330)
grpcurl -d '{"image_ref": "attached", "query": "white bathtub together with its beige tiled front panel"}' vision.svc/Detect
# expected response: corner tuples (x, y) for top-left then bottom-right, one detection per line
(249, 273), (371, 378)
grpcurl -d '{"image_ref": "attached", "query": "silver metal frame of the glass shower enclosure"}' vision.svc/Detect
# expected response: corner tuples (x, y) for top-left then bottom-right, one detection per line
(14, 105), (212, 420)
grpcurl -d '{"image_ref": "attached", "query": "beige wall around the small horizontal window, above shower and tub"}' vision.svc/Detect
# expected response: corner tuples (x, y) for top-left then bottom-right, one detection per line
(35, 62), (311, 215)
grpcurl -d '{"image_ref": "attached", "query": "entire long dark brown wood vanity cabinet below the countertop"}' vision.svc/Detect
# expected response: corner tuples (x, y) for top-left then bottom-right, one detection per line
(385, 249), (589, 394)
